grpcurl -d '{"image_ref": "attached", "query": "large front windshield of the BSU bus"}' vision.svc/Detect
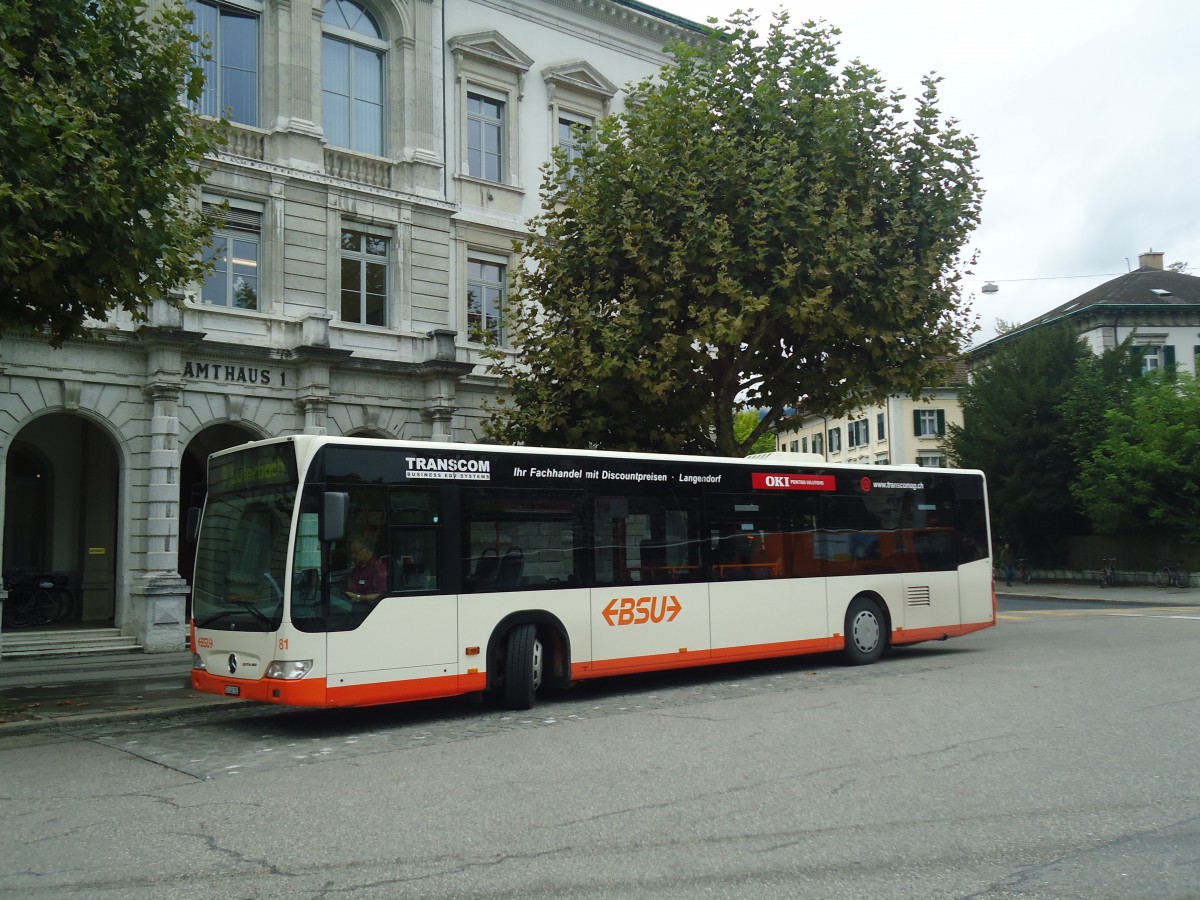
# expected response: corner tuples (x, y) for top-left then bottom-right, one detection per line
(192, 444), (296, 631)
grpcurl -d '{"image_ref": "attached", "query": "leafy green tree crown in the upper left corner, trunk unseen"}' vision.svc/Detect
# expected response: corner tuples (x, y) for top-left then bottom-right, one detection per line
(0, 0), (218, 346)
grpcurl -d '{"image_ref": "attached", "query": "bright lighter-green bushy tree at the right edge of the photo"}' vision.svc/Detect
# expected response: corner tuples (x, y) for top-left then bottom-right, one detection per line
(1074, 372), (1200, 541)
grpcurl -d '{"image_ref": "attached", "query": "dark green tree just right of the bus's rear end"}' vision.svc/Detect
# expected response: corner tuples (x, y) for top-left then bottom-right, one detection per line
(944, 324), (1091, 562)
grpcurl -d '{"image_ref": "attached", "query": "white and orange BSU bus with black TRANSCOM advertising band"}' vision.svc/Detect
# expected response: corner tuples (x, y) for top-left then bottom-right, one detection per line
(192, 436), (996, 709)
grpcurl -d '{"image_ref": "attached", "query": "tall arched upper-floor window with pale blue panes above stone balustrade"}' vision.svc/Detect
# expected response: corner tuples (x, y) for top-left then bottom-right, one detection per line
(320, 0), (384, 156)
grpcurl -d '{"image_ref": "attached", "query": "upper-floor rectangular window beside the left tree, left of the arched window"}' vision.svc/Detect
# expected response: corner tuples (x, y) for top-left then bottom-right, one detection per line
(187, 0), (258, 125)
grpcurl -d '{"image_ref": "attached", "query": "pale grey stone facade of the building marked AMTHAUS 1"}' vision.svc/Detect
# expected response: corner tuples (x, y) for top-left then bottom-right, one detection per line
(0, 0), (701, 650)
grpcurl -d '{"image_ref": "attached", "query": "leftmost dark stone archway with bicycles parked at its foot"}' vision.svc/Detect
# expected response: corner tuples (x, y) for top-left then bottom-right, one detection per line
(4, 413), (121, 625)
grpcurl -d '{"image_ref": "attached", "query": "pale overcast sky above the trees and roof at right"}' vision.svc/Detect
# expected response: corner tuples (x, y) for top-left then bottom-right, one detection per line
(649, 0), (1200, 343)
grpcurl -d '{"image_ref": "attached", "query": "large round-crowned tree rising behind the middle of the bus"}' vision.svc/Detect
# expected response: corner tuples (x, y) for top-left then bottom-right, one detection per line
(490, 14), (982, 456)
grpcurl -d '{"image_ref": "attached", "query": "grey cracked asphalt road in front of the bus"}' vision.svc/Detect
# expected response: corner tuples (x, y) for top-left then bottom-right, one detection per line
(0, 601), (1200, 898)
